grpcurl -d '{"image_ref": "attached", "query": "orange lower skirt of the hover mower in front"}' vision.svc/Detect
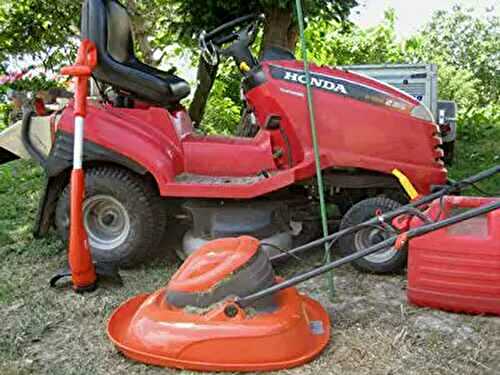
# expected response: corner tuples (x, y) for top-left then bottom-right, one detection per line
(108, 288), (330, 371)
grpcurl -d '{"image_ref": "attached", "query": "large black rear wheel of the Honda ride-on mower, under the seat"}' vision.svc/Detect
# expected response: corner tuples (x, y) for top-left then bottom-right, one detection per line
(55, 166), (166, 267)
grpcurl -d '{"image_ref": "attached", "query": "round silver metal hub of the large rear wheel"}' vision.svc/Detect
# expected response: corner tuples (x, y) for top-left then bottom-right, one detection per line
(83, 195), (130, 250)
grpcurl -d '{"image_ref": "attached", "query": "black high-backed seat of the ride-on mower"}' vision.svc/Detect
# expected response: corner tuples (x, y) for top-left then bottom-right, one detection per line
(81, 0), (190, 107)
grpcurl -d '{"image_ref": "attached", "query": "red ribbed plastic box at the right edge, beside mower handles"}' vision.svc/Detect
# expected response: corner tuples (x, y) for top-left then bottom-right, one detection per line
(407, 196), (500, 315)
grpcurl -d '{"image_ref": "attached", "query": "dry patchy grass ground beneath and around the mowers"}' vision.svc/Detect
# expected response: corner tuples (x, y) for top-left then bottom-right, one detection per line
(0, 127), (500, 375)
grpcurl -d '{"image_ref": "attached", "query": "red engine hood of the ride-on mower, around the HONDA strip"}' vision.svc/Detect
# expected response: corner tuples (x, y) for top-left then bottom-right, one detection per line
(247, 61), (446, 194)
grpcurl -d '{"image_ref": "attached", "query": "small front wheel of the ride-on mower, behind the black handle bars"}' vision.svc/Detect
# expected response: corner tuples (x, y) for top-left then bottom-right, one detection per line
(339, 197), (408, 274)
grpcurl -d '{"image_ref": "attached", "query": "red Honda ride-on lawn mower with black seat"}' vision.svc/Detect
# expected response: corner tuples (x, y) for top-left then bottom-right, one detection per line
(25, 0), (447, 272)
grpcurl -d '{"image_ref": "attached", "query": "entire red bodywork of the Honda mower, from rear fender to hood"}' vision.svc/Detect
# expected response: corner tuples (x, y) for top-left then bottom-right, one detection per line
(58, 60), (447, 198)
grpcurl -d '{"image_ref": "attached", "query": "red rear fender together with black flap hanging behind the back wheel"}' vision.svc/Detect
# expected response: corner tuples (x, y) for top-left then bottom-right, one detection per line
(33, 105), (182, 238)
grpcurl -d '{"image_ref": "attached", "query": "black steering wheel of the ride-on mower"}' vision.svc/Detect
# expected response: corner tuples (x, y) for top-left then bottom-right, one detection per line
(199, 14), (265, 66)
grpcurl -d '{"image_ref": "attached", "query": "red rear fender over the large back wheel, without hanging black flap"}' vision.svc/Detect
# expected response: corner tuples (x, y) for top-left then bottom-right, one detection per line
(55, 105), (184, 190)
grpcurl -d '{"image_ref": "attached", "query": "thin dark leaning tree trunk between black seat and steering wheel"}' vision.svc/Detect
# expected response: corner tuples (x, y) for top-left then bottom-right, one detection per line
(189, 57), (218, 127)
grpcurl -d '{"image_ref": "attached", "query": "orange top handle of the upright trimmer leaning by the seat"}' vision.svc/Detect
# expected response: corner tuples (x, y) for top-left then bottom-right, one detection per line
(61, 39), (97, 117)
